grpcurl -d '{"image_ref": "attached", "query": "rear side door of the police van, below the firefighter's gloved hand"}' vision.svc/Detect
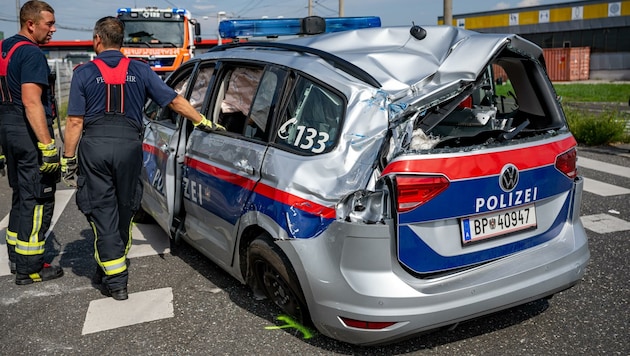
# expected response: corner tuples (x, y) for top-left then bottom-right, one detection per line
(183, 63), (285, 266)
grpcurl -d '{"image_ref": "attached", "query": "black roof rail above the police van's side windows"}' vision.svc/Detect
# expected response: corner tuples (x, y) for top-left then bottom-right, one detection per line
(208, 42), (382, 88)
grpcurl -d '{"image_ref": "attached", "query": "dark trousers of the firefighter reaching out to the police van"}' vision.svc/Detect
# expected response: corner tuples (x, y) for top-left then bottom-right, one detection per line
(76, 115), (142, 290)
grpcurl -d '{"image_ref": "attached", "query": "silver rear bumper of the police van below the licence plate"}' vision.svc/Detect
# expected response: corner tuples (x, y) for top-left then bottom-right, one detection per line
(279, 181), (590, 345)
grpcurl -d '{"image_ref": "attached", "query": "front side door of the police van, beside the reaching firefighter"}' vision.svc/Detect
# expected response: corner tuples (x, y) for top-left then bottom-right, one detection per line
(142, 62), (214, 231)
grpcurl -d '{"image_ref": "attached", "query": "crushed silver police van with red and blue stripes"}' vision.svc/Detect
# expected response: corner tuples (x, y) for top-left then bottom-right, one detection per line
(141, 18), (590, 345)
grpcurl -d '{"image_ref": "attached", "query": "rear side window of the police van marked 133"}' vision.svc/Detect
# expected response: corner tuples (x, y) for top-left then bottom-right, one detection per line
(275, 77), (345, 154)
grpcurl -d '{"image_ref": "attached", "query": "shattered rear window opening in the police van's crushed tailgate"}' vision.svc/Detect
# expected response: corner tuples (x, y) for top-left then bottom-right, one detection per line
(394, 50), (567, 153)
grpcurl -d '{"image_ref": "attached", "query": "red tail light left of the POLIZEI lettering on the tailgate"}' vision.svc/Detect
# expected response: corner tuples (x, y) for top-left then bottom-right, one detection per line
(396, 176), (450, 213)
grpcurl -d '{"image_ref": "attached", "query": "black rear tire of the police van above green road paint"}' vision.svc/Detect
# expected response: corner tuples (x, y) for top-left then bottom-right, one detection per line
(247, 235), (310, 324)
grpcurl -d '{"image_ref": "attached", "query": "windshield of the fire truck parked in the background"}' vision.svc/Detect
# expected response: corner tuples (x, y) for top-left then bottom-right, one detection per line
(124, 21), (184, 47)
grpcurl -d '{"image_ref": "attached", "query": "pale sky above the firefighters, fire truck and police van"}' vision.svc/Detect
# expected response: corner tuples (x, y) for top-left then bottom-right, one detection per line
(0, 0), (571, 41)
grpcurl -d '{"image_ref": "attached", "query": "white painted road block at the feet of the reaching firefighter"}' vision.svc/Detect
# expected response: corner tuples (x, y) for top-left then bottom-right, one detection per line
(81, 288), (175, 335)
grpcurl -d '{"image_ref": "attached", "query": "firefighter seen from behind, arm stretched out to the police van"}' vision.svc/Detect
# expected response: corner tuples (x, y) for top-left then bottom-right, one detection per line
(61, 16), (220, 300)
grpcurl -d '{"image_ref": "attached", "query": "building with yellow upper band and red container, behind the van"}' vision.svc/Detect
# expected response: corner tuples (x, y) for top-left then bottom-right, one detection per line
(438, 0), (630, 81)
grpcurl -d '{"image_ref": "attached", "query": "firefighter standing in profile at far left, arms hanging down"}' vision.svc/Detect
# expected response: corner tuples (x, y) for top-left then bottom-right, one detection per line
(0, 1), (63, 285)
